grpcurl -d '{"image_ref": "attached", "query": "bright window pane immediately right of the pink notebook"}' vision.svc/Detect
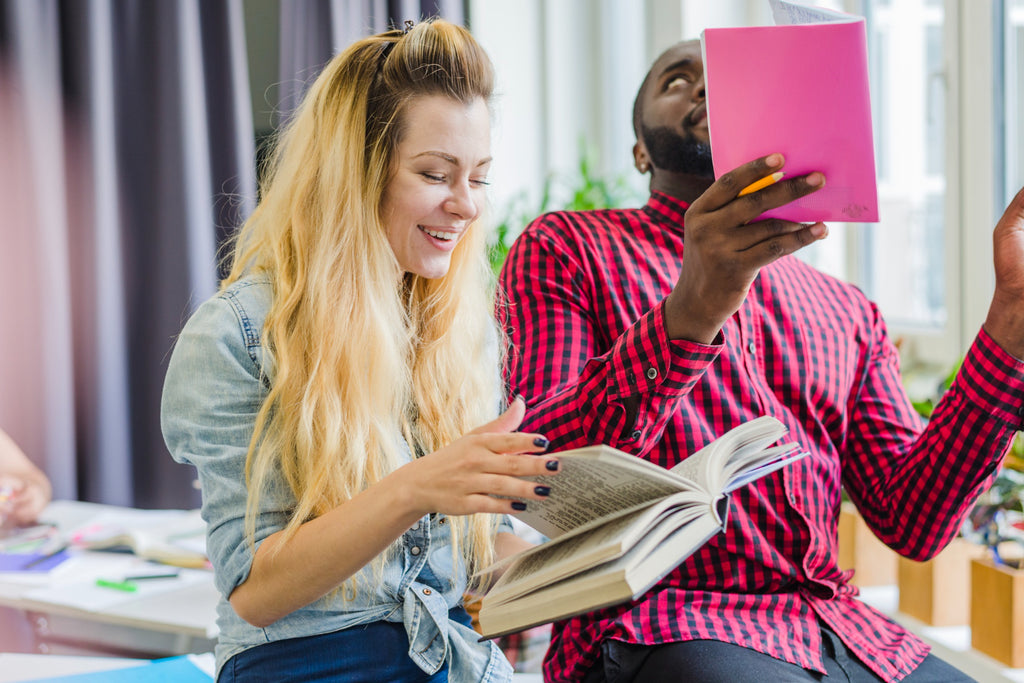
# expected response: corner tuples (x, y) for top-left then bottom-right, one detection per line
(805, 0), (949, 334)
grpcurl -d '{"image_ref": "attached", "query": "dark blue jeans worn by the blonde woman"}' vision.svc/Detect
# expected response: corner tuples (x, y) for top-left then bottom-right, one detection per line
(217, 607), (470, 683)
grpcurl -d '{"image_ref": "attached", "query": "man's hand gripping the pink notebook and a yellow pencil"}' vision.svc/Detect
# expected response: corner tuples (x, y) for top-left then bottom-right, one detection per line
(666, 154), (828, 344)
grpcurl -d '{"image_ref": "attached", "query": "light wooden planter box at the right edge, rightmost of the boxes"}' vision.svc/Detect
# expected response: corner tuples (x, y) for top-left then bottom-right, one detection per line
(971, 557), (1024, 669)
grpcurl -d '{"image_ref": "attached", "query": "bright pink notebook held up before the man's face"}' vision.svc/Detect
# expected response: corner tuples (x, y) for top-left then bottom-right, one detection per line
(701, 0), (879, 222)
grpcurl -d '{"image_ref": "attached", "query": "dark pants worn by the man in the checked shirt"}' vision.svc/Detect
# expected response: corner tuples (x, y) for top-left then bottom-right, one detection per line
(583, 629), (974, 683)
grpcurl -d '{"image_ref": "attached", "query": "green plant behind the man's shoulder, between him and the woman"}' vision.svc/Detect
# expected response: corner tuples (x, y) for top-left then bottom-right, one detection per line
(489, 141), (635, 273)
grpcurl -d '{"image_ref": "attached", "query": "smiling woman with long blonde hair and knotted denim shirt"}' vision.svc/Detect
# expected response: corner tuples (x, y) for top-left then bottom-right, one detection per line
(163, 20), (558, 682)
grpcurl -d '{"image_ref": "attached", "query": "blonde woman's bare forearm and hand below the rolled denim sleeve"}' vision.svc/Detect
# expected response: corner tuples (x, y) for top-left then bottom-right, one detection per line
(228, 400), (557, 628)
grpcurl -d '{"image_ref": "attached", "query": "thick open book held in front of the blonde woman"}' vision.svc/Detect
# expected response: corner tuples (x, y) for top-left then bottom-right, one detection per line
(479, 417), (807, 638)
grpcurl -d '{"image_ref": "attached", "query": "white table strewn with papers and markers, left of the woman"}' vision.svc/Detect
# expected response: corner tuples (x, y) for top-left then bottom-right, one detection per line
(0, 501), (219, 658)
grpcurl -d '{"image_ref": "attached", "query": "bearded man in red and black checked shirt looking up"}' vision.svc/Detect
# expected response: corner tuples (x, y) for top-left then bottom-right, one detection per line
(501, 42), (1024, 683)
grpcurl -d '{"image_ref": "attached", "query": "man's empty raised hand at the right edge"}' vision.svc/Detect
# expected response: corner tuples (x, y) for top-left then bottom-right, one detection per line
(985, 184), (1024, 359)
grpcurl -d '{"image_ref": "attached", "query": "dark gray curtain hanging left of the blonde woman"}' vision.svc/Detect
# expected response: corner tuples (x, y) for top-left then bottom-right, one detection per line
(0, 0), (255, 507)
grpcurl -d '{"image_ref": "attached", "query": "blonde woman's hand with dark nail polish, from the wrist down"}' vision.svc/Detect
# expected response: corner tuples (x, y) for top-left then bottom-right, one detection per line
(392, 398), (558, 516)
